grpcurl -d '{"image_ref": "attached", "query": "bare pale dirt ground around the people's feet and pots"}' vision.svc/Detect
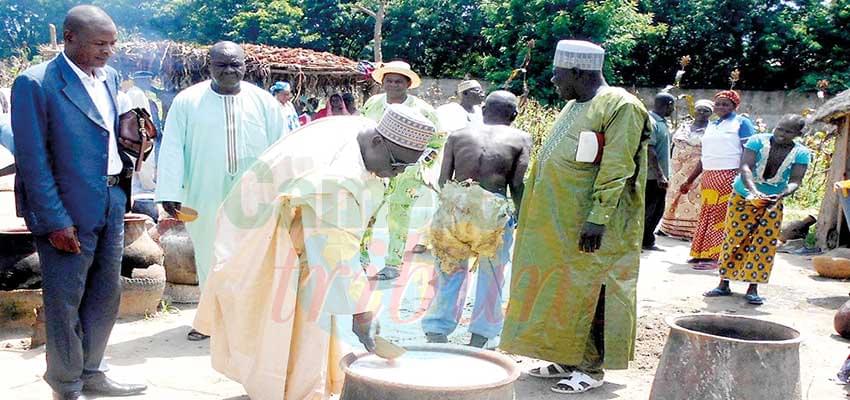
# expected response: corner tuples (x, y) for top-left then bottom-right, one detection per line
(0, 188), (850, 400)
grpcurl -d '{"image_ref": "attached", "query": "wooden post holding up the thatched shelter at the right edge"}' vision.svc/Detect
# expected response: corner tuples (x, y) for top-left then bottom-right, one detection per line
(817, 115), (850, 250)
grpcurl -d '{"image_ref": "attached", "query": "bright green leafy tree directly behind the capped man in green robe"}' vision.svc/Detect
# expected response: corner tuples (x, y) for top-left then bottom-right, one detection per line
(476, 0), (667, 101)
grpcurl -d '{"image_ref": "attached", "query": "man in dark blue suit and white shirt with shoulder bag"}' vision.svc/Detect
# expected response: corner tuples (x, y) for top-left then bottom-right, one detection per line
(12, 6), (146, 399)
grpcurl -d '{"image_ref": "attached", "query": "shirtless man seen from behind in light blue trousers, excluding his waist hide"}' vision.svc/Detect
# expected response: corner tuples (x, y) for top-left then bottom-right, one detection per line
(422, 91), (531, 347)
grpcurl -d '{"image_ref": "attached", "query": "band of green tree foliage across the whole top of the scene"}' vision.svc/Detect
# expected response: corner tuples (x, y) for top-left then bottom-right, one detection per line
(0, 0), (850, 96)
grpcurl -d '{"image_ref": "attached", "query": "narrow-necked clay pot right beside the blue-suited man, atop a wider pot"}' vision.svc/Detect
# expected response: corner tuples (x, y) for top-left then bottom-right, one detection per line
(121, 213), (163, 277)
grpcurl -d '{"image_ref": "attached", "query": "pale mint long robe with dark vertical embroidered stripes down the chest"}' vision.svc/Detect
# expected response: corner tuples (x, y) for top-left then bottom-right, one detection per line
(156, 81), (287, 287)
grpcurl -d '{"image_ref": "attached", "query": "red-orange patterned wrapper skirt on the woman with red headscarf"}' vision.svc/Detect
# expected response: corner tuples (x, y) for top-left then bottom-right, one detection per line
(691, 169), (738, 260)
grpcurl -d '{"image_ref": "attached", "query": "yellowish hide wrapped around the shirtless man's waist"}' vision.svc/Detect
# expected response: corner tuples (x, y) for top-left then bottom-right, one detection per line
(429, 181), (510, 273)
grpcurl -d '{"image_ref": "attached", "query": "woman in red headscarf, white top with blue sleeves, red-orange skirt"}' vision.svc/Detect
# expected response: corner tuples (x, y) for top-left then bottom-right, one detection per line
(679, 90), (755, 269)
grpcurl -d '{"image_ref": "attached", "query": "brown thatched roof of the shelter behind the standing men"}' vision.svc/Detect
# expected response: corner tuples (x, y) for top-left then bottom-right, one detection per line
(39, 41), (373, 95)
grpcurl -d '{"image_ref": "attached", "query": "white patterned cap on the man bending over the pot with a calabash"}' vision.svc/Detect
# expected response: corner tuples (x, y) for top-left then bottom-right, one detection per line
(376, 104), (436, 151)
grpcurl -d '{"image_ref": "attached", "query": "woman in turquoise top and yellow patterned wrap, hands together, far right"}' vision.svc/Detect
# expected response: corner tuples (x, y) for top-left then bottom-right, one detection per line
(705, 114), (811, 305)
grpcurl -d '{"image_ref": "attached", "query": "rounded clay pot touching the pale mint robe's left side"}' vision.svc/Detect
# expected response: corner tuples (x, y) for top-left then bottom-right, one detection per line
(159, 222), (198, 285)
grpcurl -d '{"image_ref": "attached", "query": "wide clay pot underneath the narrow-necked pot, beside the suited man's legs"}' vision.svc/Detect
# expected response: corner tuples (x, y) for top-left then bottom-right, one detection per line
(118, 265), (165, 317)
